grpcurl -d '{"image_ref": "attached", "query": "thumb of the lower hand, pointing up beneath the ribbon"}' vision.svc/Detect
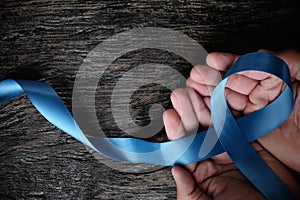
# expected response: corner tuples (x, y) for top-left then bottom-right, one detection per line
(172, 166), (209, 200)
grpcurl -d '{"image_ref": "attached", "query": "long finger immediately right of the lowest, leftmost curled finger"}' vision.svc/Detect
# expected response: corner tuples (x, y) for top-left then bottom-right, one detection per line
(171, 88), (199, 135)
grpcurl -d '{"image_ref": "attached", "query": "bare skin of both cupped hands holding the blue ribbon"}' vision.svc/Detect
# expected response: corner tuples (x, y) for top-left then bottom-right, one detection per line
(164, 50), (300, 200)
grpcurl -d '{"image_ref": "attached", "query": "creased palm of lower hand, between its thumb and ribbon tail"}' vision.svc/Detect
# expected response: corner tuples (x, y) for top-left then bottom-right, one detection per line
(173, 160), (263, 200)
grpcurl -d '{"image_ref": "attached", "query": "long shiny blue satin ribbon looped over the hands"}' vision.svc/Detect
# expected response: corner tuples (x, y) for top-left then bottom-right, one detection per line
(0, 52), (295, 200)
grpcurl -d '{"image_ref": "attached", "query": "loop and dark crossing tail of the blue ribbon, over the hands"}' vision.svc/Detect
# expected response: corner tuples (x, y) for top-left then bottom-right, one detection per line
(211, 53), (294, 200)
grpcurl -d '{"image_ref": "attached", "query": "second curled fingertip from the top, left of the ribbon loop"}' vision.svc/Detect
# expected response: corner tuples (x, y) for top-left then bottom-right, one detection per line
(190, 65), (222, 86)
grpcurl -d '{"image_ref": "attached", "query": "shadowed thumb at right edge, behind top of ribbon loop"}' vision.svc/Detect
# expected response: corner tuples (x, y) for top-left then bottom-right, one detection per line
(259, 49), (300, 81)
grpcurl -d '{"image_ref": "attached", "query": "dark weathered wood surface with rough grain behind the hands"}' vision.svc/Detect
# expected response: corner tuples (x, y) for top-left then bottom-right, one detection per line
(0, 0), (300, 199)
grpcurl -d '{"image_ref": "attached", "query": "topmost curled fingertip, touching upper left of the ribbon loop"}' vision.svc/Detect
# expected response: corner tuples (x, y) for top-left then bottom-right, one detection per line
(206, 52), (239, 71)
